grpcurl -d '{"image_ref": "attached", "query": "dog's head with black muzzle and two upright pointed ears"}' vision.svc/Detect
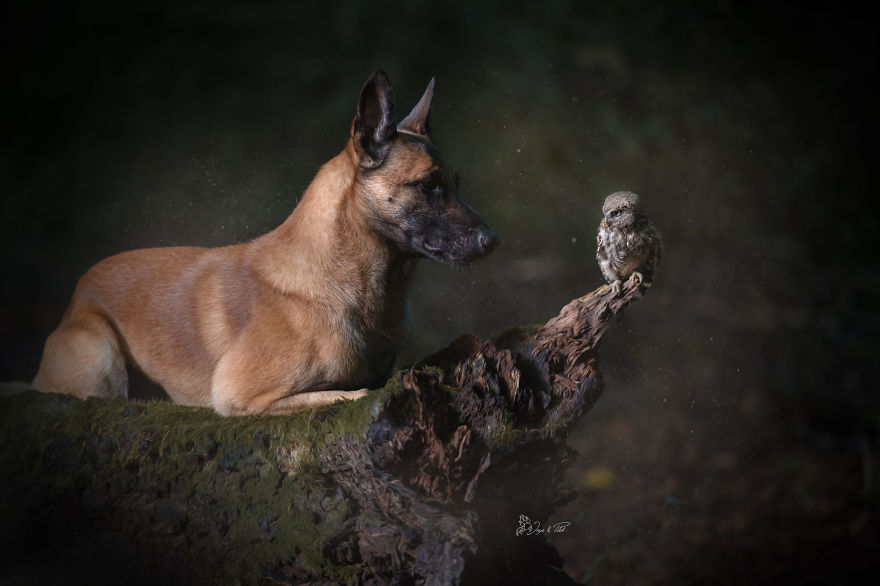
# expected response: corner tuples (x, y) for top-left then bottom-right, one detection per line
(351, 71), (500, 264)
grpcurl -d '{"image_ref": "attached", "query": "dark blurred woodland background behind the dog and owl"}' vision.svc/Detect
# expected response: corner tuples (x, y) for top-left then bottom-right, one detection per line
(0, 0), (880, 584)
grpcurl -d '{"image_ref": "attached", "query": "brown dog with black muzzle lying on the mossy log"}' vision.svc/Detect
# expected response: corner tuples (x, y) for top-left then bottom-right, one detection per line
(34, 71), (498, 415)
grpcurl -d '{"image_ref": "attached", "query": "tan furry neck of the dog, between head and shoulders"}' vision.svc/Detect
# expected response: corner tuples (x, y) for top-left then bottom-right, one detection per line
(251, 148), (412, 325)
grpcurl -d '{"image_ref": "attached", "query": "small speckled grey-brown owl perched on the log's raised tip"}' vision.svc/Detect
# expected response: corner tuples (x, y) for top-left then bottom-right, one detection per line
(596, 191), (662, 295)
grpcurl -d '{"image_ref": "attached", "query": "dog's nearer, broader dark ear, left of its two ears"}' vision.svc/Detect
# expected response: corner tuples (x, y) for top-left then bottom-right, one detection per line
(352, 69), (395, 168)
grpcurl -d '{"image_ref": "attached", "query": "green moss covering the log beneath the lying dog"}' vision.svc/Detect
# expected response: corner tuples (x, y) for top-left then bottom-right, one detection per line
(0, 373), (414, 583)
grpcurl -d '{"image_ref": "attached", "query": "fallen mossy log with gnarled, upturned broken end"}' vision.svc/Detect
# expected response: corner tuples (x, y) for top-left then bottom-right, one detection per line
(0, 284), (644, 584)
